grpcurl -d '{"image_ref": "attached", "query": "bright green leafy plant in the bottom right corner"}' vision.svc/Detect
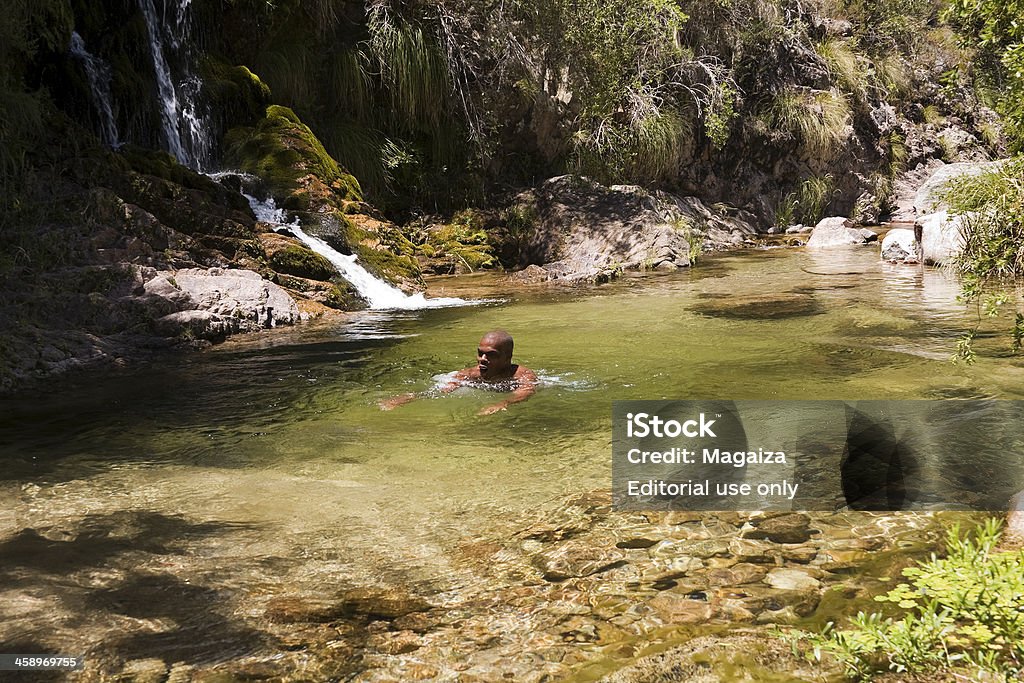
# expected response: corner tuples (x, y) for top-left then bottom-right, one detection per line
(801, 519), (1024, 681)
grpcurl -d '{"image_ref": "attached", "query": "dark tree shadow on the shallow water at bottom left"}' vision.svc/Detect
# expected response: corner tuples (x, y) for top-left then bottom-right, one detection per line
(0, 510), (269, 664)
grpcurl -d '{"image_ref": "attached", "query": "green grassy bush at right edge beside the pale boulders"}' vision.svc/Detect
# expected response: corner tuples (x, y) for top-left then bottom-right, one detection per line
(945, 157), (1024, 362)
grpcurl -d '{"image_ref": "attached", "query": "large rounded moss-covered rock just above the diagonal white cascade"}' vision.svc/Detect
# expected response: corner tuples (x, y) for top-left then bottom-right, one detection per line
(224, 104), (362, 205)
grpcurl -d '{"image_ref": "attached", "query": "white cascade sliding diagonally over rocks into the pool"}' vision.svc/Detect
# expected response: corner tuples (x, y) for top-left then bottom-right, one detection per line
(236, 191), (471, 310)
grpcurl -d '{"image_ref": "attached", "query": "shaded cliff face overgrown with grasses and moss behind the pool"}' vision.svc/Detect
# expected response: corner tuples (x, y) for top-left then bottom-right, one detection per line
(0, 0), (1004, 387)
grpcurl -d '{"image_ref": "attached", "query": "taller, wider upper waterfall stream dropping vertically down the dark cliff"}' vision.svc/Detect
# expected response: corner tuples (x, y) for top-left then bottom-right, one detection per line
(138, 0), (212, 169)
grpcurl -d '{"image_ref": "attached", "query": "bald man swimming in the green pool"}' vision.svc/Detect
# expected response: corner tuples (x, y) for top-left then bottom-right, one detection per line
(380, 330), (537, 415)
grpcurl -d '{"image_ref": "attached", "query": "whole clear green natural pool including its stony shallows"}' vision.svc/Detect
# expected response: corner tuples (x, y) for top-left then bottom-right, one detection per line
(0, 248), (1024, 681)
